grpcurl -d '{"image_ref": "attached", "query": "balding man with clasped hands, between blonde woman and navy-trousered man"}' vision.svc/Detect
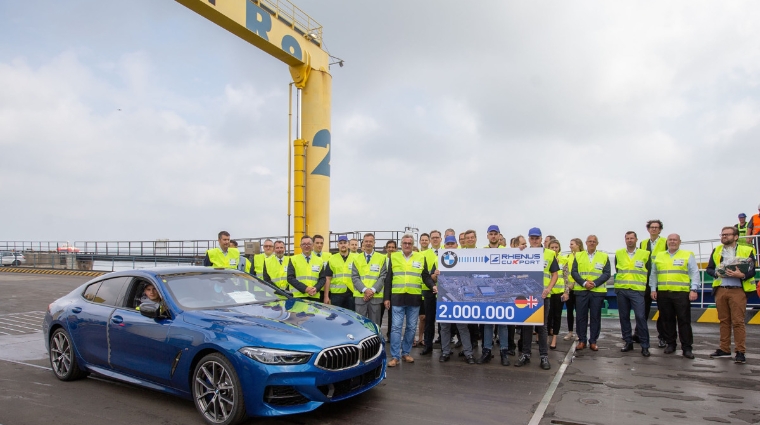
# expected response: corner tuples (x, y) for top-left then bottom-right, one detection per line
(571, 235), (610, 351)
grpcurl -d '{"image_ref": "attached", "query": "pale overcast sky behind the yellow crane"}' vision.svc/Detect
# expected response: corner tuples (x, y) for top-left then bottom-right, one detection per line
(0, 0), (760, 250)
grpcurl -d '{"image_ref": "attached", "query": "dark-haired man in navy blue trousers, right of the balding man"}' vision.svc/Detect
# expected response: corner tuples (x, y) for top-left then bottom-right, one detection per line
(615, 231), (651, 357)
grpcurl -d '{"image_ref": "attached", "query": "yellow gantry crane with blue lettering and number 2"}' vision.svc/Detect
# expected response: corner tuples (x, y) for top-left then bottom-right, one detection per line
(176, 0), (332, 252)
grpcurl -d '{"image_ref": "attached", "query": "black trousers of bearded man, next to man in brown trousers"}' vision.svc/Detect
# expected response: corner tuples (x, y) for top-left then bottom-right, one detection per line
(657, 291), (694, 350)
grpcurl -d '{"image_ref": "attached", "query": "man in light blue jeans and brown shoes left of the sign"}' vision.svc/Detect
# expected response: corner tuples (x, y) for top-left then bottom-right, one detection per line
(383, 234), (440, 367)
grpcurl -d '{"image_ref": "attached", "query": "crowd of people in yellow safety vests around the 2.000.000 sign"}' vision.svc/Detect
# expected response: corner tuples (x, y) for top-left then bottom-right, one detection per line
(204, 220), (756, 370)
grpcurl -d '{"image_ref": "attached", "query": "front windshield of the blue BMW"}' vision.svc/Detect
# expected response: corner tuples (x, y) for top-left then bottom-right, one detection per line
(160, 272), (282, 309)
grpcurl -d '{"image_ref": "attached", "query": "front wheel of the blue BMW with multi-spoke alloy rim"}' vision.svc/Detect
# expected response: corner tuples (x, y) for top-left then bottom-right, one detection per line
(191, 353), (245, 425)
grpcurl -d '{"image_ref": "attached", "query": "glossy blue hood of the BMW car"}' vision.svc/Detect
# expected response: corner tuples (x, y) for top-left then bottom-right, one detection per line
(183, 298), (377, 349)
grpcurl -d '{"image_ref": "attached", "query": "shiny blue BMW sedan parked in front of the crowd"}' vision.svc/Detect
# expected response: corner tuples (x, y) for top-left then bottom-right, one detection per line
(43, 267), (386, 425)
